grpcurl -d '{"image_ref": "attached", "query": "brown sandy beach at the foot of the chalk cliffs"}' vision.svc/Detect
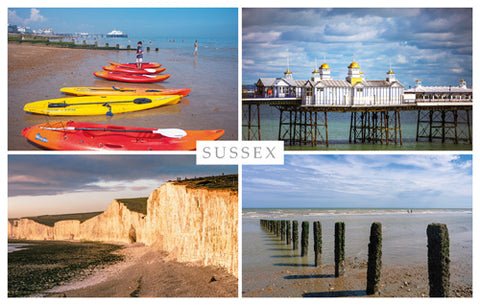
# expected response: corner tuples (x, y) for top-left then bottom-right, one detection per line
(43, 245), (238, 297)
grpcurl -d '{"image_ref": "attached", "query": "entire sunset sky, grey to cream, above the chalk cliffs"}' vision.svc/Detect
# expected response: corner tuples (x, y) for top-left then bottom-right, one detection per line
(8, 155), (237, 218)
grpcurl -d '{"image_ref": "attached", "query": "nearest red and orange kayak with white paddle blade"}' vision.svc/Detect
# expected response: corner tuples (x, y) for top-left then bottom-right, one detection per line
(22, 121), (224, 151)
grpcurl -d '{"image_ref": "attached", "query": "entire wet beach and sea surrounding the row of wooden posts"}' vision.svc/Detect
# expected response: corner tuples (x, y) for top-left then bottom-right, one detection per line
(242, 209), (473, 297)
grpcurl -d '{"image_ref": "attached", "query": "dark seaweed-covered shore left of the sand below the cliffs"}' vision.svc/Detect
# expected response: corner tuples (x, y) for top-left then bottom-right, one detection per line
(8, 241), (124, 297)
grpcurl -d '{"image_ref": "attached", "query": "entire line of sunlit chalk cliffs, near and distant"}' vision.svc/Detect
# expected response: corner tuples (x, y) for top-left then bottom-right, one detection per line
(8, 182), (238, 276)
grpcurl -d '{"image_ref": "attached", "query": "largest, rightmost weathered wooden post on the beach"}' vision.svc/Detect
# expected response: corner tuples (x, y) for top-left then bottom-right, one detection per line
(427, 223), (450, 297)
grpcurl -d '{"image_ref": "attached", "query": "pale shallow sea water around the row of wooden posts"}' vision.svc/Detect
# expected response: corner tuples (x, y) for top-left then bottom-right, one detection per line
(242, 209), (472, 281)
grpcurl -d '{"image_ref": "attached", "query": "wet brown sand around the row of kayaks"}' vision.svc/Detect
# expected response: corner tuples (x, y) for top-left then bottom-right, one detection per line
(8, 43), (238, 150)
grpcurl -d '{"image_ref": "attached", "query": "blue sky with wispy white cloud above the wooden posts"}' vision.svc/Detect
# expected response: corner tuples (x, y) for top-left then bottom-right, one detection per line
(242, 154), (472, 208)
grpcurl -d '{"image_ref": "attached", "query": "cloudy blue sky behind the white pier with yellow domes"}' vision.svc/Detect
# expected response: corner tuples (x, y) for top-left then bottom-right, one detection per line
(242, 8), (472, 88)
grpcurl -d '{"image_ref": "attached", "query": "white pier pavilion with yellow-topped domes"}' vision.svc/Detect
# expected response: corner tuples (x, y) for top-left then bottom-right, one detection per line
(254, 61), (472, 107)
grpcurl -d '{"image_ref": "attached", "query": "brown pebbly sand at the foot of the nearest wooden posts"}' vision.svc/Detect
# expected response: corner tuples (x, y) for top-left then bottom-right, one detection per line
(242, 260), (472, 297)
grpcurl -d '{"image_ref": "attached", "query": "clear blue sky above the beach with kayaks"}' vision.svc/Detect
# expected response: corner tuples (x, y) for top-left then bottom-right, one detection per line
(8, 8), (238, 39)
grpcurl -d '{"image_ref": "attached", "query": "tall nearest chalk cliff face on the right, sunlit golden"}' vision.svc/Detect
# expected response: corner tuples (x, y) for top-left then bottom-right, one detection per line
(145, 182), (238, 275)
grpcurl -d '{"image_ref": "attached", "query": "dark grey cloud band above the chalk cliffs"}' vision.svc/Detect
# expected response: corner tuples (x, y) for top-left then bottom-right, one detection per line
(8, 155), (237, 196)
